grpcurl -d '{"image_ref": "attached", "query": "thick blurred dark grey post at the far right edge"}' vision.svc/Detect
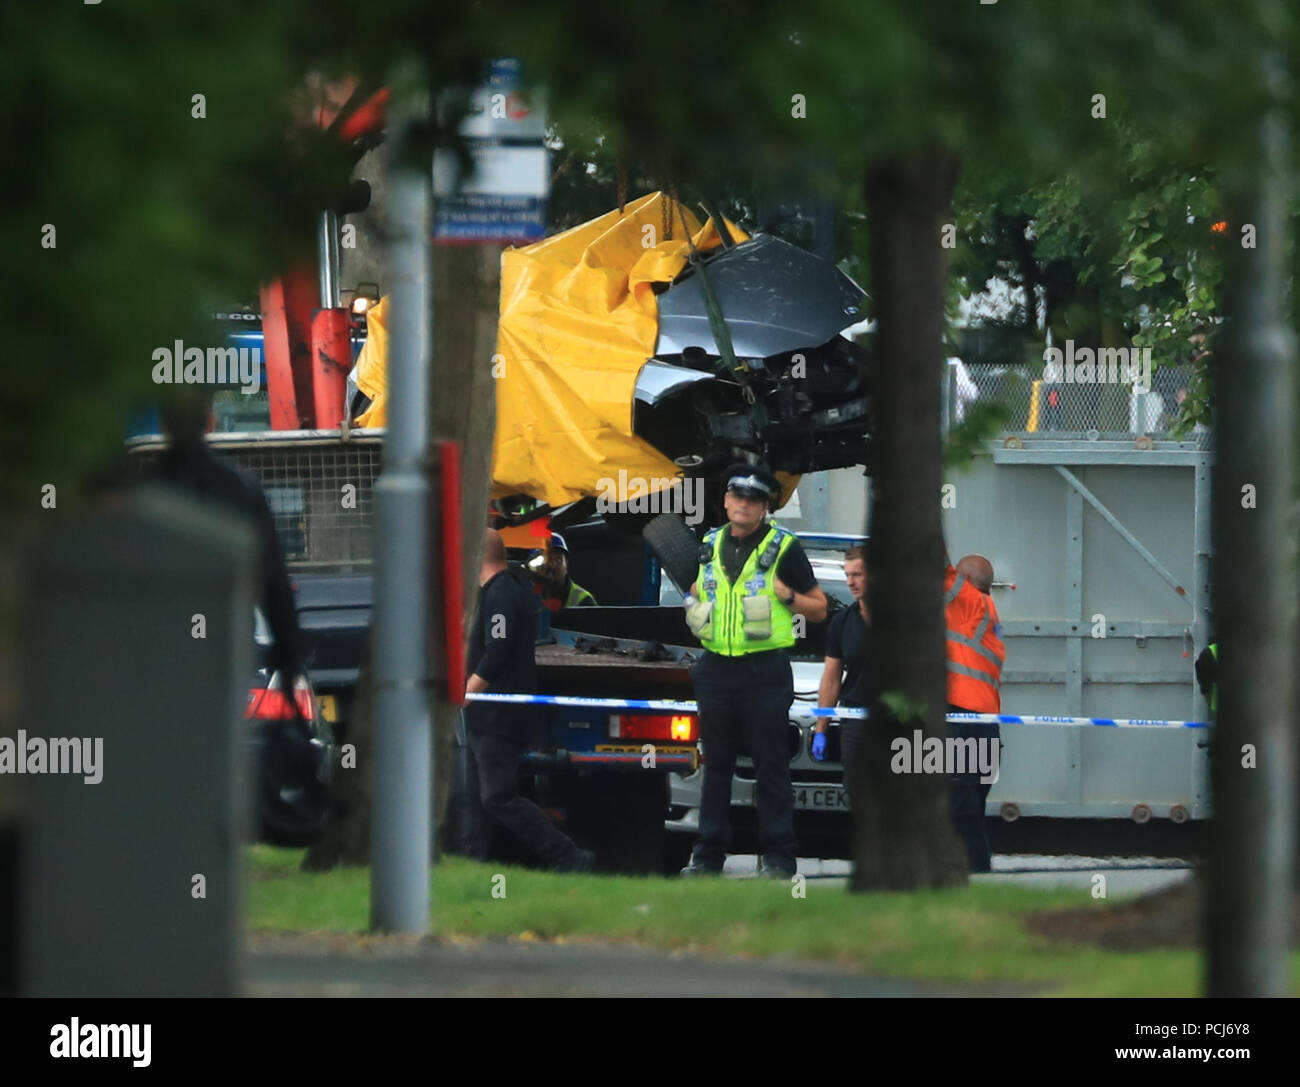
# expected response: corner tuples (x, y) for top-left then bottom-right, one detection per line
(1206, 72), (1297, 996)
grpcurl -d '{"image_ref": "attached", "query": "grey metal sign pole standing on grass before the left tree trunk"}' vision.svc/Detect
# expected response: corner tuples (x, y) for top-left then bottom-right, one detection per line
(371, 87), (433, 934)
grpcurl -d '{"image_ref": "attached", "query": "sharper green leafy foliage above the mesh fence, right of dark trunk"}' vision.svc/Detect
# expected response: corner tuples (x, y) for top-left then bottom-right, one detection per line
(953, 140), (1240, 428)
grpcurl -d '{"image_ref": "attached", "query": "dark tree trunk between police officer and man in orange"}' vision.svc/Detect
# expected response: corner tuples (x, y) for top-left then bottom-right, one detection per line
(852, 151), (966, 891)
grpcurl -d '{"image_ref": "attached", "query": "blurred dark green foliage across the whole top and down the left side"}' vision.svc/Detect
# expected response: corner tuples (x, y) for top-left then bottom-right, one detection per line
(0, 0), (1295, 493)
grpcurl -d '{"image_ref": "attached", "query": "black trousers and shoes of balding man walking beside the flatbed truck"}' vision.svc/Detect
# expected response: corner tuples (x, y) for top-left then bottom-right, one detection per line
(458, 728), (577, 867)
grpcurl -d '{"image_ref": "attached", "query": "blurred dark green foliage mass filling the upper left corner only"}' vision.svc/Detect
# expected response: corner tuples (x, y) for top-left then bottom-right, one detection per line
(0, 0), (476, 501)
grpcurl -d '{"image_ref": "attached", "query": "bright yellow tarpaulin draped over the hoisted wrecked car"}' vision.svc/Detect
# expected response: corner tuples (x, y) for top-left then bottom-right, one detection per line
(358, 192), (748, 506)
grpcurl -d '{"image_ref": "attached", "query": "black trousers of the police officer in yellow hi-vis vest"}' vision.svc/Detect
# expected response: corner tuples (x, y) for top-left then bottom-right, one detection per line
(693, 650), (798, 869)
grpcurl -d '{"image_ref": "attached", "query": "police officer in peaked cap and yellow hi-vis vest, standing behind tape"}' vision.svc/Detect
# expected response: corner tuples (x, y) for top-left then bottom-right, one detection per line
(681, 464), (827, 879)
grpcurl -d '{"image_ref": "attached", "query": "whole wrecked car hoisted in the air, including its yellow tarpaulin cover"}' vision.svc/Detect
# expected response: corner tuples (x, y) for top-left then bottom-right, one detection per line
(348, 192), (870, 515)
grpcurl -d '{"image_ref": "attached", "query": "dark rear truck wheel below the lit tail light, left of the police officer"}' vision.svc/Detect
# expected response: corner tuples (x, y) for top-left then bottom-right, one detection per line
(564, 774), (668, 875)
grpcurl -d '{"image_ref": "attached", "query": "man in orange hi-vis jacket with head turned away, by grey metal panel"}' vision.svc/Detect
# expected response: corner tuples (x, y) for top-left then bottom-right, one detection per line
(944, 555), (1006, 872)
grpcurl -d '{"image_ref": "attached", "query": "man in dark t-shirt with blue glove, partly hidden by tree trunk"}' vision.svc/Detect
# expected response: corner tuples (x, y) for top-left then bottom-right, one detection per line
(813, 547), (875, 804)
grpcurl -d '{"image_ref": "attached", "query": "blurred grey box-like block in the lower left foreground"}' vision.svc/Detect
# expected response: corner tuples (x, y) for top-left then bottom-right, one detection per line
(17, 489), (256, 997)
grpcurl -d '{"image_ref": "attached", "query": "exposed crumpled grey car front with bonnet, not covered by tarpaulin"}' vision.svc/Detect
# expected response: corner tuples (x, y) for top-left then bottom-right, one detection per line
(633, 227), (868, 475)
